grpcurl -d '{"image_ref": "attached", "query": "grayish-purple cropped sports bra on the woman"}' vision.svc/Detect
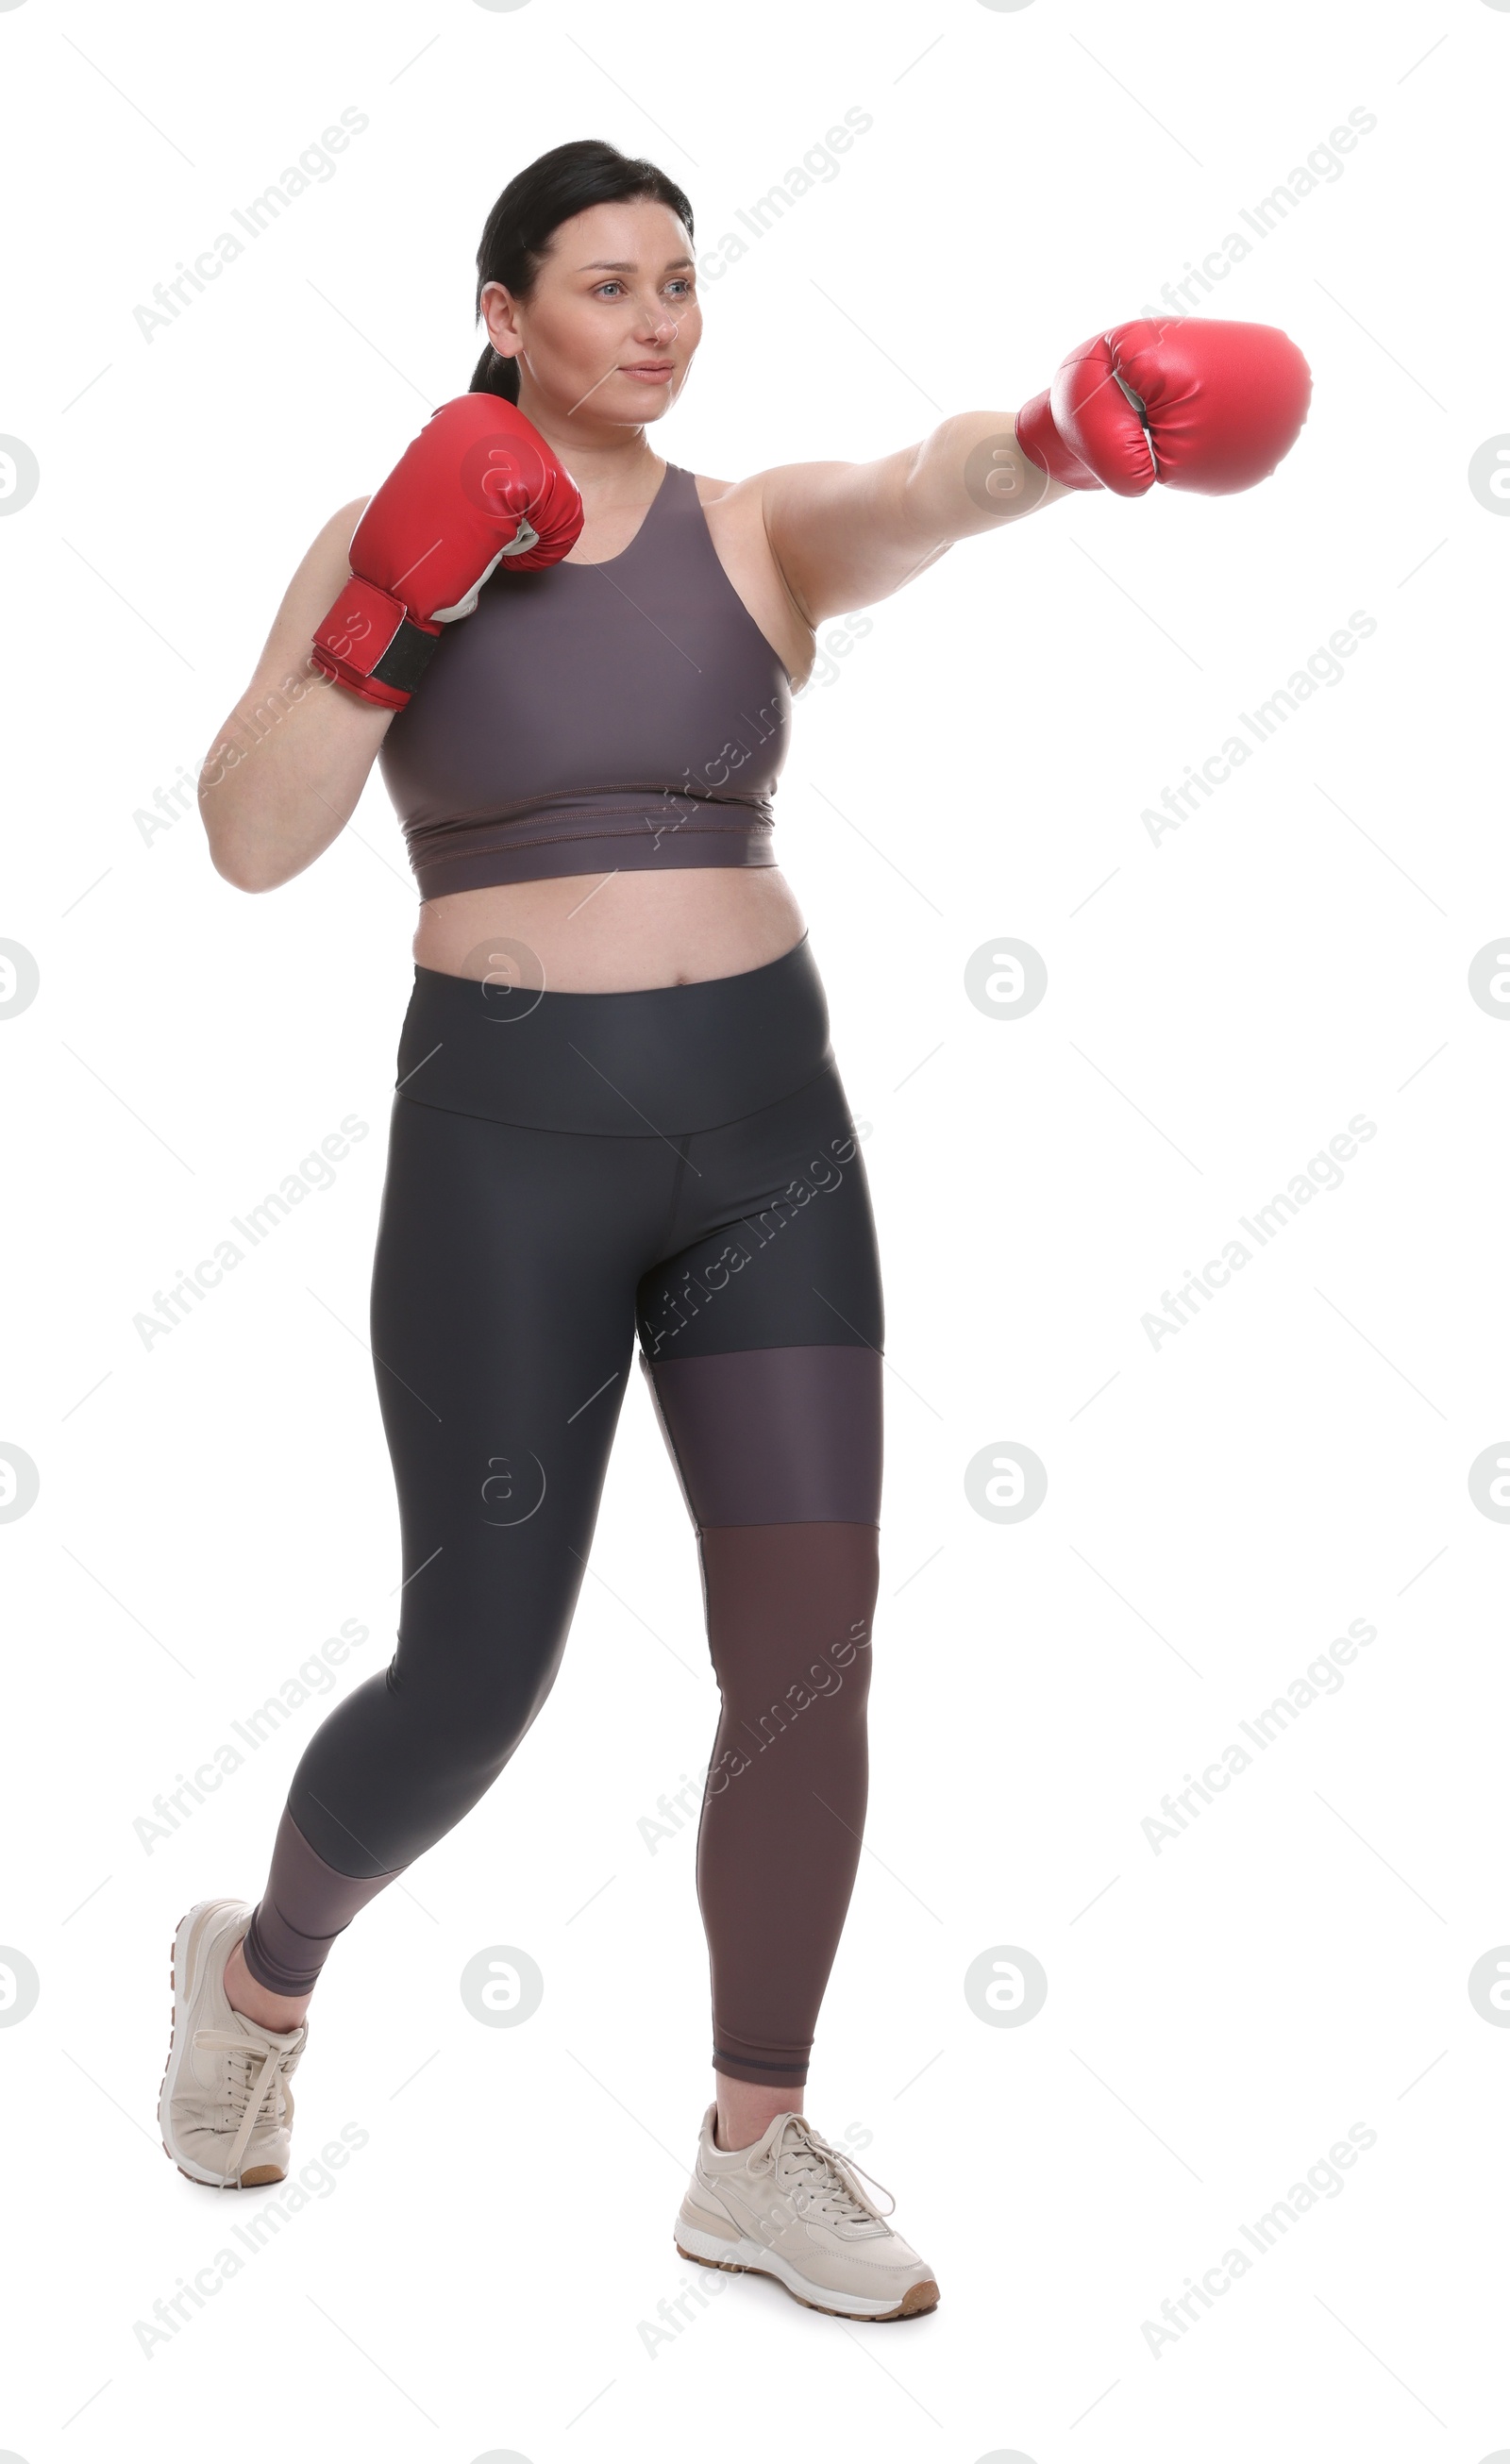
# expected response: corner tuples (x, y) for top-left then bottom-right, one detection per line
(379, 463), (791, 899)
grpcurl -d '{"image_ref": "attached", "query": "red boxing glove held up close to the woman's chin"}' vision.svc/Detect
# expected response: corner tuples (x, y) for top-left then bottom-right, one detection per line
(310, 394), (581, 710)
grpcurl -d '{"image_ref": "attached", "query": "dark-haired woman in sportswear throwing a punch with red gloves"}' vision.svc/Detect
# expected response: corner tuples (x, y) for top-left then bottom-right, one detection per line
(160, 142), (1308, 2319)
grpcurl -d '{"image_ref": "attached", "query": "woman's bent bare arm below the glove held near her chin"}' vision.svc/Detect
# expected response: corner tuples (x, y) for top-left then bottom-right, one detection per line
(199, 497), (394, 890)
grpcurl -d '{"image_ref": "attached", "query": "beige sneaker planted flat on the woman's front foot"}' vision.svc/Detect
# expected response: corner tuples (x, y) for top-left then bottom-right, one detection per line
(675, 2104), (938, 2319)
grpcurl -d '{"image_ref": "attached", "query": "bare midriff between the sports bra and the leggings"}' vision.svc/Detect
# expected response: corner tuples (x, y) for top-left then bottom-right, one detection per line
(413, 864), (803, 993)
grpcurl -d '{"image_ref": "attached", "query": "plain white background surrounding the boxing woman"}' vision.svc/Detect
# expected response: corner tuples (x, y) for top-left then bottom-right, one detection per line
(0, 0), (1510, 2464)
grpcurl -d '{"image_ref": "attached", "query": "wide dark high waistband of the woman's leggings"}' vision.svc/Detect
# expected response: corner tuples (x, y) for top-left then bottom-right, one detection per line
(394, 934), (832, 1138)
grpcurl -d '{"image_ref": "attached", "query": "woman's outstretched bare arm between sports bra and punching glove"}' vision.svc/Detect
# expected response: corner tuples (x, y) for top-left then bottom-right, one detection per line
(751, 411), (1074, 626)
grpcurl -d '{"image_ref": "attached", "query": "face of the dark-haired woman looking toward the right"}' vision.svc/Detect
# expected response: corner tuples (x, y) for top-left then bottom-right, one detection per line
(483, 197), (702, 436)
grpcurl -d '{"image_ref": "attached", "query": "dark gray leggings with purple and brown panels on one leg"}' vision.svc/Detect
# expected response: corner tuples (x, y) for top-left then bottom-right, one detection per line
(246, 939), (884, 2087)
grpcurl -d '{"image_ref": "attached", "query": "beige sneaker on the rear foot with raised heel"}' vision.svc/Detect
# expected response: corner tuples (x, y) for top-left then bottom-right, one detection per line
(158, 1900), (308, 2190)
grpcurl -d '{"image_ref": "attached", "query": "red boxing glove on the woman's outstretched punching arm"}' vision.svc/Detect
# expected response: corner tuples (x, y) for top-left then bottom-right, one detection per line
(1017, 315), (1311, 495)
